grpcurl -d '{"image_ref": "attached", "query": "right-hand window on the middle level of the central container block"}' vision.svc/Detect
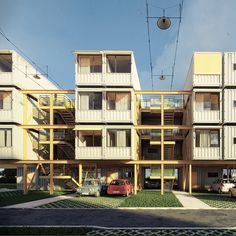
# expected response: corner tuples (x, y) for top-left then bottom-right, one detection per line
(107, 92), (131, 111)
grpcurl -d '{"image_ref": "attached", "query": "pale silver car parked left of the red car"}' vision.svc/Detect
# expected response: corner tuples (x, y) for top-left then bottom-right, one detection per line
(76, 179), (102, 197)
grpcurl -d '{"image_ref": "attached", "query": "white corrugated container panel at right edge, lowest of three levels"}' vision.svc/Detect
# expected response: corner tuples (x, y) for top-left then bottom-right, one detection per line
(224, 126), (236, 160)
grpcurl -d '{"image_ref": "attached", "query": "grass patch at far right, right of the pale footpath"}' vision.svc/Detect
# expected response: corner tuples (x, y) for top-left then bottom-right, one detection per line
(193, 192), (236, 208)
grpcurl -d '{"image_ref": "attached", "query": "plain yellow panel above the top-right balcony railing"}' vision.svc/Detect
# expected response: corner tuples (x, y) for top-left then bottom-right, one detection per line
(193, 52), (222, 75)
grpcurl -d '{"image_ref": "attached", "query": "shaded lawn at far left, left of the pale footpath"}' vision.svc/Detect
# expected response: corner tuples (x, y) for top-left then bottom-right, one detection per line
(0, 191), (68, 207)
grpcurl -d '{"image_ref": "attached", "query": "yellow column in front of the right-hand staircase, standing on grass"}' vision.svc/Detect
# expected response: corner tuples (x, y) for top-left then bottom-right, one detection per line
(161, 95), (165, 195)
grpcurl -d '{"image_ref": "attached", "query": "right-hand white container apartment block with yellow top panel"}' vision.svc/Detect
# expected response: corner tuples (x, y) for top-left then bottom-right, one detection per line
(185, 52), (236, 188)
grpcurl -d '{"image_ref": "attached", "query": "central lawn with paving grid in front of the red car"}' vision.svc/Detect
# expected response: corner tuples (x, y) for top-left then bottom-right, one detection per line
(38, 190), (182, 208)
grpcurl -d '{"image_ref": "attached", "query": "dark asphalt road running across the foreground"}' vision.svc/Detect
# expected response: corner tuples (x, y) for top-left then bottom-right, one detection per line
(0, 208), (236, 228)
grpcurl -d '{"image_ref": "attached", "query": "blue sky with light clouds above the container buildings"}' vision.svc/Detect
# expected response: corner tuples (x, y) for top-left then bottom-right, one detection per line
(0, 0), (236, 89)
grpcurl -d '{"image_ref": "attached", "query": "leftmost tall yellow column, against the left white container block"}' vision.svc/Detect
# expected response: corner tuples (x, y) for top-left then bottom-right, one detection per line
(22, 94), (28, 194)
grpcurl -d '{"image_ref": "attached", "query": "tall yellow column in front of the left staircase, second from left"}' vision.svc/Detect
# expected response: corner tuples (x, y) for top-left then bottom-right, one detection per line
(49, 94), (54, 195)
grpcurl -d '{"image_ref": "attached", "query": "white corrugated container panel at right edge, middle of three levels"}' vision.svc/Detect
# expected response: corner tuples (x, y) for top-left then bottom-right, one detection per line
(224, 89), (236, 122)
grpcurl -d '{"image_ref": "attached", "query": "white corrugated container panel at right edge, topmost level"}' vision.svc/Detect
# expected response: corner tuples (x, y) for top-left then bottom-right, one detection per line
(224, 52), (236, 86)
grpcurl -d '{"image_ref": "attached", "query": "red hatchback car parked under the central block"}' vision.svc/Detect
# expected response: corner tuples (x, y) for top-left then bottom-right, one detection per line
(107, 179), (133, 196)
